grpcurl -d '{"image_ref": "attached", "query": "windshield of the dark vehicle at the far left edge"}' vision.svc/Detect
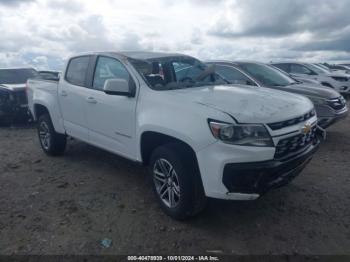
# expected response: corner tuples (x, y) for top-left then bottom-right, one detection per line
(0, 68), (38, 84)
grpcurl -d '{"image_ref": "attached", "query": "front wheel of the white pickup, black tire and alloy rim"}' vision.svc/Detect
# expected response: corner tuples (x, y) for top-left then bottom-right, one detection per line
(149, 144), (206, 220)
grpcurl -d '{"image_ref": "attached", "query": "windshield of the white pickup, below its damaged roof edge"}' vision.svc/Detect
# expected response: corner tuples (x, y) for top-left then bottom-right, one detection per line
(129, 56), (227, 90)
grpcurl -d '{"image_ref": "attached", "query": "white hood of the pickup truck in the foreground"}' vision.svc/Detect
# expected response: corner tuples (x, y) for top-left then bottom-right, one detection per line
(169, 85), (313, 124)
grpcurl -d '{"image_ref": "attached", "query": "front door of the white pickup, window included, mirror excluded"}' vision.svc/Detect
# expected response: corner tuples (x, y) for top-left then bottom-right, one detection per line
(85, 56), (136, 158)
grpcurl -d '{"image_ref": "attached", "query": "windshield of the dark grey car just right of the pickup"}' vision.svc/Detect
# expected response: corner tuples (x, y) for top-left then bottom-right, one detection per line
(238, 63), (297, 86)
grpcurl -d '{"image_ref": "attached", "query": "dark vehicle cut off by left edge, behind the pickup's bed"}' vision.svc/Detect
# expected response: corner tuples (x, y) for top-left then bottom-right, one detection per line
(0, 68), (38, 124)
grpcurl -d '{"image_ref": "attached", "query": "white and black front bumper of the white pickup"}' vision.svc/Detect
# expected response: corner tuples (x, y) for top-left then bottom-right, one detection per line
(196, 126), (321, 200)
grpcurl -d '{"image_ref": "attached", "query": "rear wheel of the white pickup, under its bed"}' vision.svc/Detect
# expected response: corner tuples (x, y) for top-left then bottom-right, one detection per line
(38, 114), (67, 156)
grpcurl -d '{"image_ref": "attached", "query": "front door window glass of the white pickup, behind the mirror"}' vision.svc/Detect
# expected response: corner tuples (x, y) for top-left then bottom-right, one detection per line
(93, 56), (130, 90)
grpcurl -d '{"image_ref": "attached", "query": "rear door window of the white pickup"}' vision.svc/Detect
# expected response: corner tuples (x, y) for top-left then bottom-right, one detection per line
(66, 56), (90, 86)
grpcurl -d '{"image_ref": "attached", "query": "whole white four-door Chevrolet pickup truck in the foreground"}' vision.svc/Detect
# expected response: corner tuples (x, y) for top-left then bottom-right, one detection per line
(27, 52), (319, 219)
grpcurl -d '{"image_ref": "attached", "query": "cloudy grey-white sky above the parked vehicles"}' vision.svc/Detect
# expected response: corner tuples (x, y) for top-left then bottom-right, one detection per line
(0, 0), (350, 69)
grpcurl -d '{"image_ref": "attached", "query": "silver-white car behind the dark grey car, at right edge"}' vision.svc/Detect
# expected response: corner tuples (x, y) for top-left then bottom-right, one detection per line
(272, 62), (350, 96)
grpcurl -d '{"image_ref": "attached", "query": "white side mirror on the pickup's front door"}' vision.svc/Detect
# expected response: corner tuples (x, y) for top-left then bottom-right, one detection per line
(103, 78), (135, 97)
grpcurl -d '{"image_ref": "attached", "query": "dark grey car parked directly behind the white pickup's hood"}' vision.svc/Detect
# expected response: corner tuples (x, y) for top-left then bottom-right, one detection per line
(207, 61), (348, 128)
